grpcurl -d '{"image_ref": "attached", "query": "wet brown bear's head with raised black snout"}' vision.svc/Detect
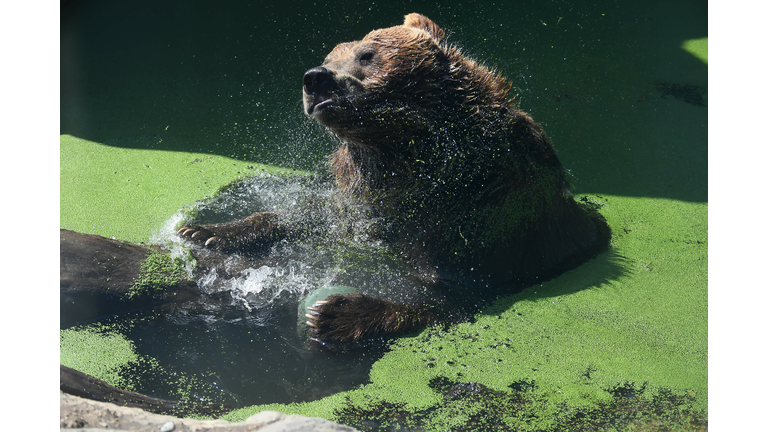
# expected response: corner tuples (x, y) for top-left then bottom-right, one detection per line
(303, 13), (510, 145)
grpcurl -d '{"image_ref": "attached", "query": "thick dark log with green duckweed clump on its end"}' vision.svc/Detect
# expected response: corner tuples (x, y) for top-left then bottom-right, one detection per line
(59, 229), (200, 328)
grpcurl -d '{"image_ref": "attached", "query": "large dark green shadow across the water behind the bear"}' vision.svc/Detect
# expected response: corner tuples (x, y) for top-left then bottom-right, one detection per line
(61, 0), (707, 202)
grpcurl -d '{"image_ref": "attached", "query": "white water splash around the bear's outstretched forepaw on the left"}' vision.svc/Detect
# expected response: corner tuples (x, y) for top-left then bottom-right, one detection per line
(152, 174), (341, 312)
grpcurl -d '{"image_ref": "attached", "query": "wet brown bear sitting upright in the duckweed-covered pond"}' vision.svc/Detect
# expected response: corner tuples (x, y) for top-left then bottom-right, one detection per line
(179, 13), (610, 344)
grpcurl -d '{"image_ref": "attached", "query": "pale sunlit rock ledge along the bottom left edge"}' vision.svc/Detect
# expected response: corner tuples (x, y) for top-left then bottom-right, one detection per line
(59, 392), (357, 432)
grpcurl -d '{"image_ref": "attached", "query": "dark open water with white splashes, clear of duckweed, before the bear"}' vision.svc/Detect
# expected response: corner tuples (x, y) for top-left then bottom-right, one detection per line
(70, 174), (452, 406)
